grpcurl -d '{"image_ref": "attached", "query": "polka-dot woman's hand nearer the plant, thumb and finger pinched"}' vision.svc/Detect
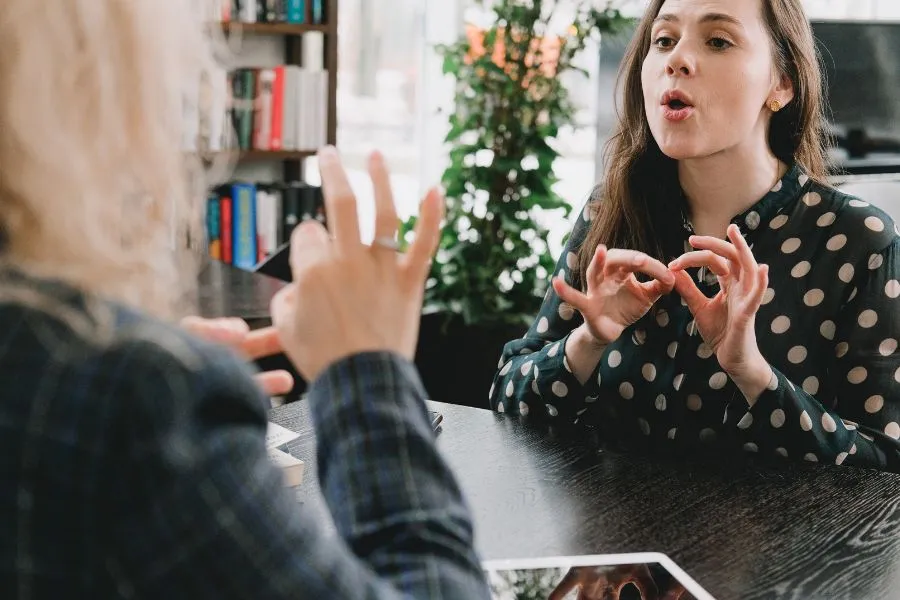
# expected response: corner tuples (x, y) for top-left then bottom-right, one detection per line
(552, 244), (675, 346)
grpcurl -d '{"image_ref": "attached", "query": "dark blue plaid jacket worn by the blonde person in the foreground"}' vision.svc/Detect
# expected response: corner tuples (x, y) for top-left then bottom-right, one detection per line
(0, 278), (489, 600)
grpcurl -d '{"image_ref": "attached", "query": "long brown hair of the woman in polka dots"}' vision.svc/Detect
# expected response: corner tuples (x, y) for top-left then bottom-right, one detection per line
(578, 0), (827, 285)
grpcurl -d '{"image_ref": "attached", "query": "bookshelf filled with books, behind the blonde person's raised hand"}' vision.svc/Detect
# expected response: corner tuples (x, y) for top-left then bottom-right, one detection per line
(202, 0), (338, 270)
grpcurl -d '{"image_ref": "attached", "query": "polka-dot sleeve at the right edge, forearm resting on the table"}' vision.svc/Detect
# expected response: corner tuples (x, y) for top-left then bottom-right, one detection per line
(736, 237), (900, 472)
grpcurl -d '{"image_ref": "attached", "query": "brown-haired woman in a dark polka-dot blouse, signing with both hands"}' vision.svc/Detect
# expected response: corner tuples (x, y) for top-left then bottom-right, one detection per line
(490, 0), (900, 471)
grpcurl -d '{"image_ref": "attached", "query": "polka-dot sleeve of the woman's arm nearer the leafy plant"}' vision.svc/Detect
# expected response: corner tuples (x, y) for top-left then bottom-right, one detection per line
(490, 201), (600, 421)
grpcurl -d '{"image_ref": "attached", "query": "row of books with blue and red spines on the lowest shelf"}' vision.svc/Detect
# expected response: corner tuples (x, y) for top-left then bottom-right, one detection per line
(206, 181), (325, 271)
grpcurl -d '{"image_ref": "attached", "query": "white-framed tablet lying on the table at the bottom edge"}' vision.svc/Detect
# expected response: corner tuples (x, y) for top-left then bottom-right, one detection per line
(482, 552), (714, 600)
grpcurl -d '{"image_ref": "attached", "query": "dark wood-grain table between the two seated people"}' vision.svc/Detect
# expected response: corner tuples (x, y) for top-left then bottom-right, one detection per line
(271, 400), (900, 600)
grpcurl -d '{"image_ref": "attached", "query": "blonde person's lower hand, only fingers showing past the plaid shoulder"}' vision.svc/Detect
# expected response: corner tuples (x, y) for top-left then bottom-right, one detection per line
(181, 316), (294, 396)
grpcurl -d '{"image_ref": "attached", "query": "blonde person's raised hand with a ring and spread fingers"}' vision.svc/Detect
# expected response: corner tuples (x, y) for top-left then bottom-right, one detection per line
(272, 147), (444, 381)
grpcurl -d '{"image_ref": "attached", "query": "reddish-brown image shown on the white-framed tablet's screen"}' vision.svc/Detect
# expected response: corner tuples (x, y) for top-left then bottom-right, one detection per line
(548, 565), (659, 600)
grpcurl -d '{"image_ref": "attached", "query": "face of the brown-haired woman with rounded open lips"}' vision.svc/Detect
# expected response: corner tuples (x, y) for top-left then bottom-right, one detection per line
(641, 0), (793, 160)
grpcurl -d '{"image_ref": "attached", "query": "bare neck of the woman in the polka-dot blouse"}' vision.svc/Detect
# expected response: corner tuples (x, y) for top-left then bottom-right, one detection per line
(678, 147), (787, 238)
